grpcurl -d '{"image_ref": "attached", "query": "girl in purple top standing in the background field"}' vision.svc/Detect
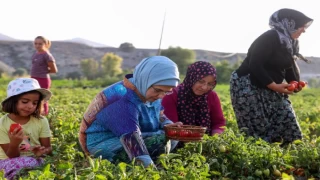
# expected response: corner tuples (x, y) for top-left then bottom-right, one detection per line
(31, 36), (58, 115)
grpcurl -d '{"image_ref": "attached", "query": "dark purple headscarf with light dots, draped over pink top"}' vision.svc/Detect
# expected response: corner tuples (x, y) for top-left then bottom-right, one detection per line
(177, 61), (216, 132)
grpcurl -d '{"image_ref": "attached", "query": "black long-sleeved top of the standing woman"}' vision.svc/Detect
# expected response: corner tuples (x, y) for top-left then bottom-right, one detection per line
(236, 30), (300, 88)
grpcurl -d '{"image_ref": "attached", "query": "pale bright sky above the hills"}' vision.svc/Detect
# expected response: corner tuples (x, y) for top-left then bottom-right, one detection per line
(0, 0), (320, 57)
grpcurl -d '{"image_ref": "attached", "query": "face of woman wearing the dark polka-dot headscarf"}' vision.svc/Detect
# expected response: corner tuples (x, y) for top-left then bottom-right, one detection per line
(192, 75), (216, 96)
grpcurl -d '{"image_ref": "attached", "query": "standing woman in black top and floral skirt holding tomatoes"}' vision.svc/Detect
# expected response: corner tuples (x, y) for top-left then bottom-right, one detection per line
(230, 9), (313, 144)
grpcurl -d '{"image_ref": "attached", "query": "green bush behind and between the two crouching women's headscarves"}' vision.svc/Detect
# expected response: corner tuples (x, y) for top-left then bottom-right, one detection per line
(161, 47), (195, 74)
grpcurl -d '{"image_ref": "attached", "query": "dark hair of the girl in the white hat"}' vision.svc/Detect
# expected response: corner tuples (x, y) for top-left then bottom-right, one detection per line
(2, 90), (43, 118)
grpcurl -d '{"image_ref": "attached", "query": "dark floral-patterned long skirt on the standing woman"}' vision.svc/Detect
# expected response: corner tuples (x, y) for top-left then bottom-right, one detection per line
(230, 72), (302, 144)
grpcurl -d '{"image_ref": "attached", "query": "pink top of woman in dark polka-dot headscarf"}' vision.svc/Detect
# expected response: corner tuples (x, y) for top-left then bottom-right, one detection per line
(162, 88), (226, 134)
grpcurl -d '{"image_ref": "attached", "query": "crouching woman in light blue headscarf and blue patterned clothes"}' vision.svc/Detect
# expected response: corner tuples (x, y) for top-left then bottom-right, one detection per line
(79, 56), (179, 166)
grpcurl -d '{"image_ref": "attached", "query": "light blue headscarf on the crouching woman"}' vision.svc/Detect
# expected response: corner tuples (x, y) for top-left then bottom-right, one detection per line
(129, 56), (180, 97)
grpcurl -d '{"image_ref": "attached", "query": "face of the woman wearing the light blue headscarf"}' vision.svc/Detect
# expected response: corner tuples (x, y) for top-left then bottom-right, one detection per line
(146, 85), (174, 102)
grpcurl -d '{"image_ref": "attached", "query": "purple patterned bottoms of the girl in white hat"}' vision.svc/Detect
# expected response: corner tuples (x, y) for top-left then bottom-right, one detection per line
(0, 156), (44, 180)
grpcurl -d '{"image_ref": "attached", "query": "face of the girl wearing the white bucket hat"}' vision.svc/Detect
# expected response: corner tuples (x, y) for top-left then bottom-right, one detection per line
(17, 92), (40, 117)
